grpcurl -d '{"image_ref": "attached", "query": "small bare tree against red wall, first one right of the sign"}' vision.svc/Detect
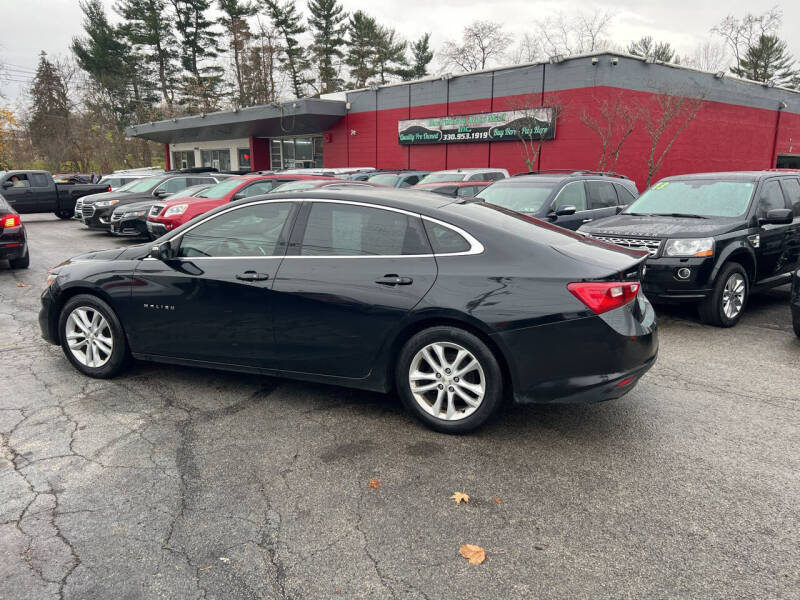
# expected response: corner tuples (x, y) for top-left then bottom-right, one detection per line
(579, 92), (641, 171)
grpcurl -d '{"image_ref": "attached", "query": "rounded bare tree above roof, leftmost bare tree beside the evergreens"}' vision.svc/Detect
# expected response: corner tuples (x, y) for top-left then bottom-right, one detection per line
(439, 21), (513, 72)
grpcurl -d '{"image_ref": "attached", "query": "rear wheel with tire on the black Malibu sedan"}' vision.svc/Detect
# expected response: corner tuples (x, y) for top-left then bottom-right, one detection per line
(395, 327), (503, 433)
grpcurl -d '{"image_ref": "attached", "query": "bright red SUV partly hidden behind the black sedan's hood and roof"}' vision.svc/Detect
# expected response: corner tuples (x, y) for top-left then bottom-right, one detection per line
(147, 174), (334, 238)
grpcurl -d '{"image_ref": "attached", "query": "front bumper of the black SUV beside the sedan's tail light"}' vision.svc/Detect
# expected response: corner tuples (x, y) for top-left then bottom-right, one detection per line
(642, 257), (714, 303)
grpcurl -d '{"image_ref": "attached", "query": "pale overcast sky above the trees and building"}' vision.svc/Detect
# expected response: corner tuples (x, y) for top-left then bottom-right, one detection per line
(0, 0), (800, 103)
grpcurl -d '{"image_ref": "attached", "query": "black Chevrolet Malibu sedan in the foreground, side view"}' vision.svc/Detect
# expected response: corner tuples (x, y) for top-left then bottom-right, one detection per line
(39, 188), (658, 432)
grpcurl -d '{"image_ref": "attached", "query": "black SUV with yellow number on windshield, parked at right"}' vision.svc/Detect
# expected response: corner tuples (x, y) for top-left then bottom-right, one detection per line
(580, 170), (800, 327)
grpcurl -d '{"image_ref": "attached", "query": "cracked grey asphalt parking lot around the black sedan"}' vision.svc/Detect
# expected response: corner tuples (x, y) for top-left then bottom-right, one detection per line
(0, 215), (800, 600)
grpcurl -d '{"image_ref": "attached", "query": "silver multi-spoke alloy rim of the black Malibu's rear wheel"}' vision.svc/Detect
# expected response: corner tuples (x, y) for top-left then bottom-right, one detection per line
(408, 342), (486, 421)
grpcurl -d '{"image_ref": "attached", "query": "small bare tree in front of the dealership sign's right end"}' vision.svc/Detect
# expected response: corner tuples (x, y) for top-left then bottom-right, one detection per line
(506, 94), (564, 171)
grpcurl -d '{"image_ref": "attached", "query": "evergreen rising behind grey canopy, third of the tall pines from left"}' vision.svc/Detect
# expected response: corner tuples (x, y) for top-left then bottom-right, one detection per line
(170, 0), (222, 113)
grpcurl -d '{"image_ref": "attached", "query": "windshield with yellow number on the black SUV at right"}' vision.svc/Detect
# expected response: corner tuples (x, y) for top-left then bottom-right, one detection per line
(624, 179), (755, 217)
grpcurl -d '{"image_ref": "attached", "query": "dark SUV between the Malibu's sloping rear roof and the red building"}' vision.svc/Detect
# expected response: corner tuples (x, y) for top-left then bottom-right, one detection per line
(475, 169), (639, 231)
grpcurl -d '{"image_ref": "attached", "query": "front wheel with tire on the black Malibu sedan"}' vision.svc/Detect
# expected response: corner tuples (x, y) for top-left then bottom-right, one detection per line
(58, 294), (128, 379)
